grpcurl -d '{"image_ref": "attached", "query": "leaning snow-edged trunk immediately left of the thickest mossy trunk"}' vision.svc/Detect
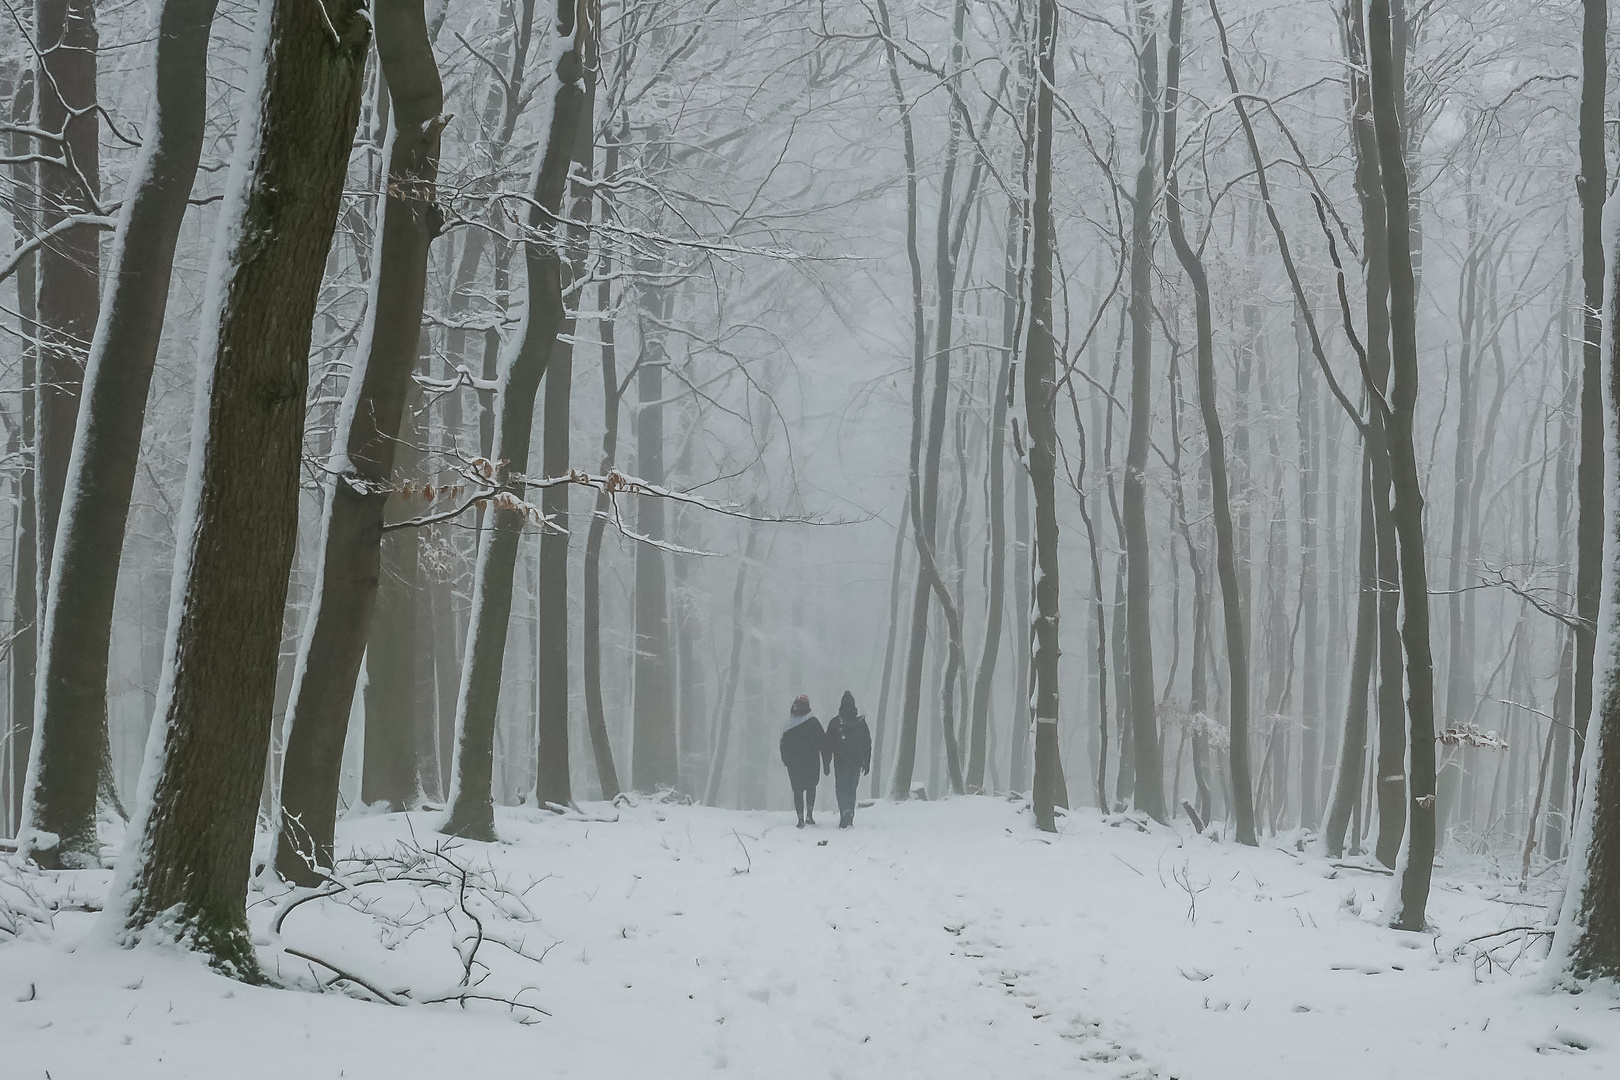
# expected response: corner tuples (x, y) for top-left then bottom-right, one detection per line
(21, 0), (217, 866)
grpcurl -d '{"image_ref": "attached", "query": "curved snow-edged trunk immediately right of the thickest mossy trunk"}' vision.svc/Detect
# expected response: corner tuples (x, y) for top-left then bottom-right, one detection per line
(275, 0), (446, 886)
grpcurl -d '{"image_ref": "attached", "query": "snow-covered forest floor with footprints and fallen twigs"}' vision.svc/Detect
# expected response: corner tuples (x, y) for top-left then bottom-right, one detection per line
(0, 792), (1620, 1080)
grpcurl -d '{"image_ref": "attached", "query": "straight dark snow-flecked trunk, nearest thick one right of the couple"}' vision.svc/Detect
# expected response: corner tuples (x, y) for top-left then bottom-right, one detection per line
(1024, 0), (1063, 832)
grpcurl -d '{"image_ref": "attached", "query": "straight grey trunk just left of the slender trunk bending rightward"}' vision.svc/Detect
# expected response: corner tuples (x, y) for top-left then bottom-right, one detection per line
(1124, 2), (1166, 821)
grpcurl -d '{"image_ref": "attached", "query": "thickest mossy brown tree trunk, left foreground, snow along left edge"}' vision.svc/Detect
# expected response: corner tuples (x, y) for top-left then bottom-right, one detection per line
(107, 0), (370, 980)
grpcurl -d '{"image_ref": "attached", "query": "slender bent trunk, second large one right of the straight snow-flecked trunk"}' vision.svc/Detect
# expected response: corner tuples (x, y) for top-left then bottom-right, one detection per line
(1165, 0), (1256, 845)
